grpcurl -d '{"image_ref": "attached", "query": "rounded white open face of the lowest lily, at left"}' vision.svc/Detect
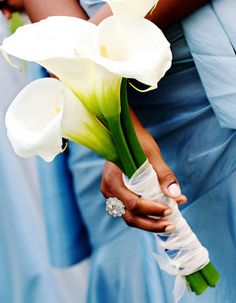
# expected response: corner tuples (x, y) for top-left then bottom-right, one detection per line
(6, 78), (64, 161)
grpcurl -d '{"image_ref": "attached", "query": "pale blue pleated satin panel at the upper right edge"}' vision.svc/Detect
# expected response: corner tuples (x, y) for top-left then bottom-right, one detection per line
(183, 0), (236, 129)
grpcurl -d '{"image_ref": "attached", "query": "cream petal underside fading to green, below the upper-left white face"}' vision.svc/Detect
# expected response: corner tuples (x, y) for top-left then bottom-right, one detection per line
(39, 53), (121, 118)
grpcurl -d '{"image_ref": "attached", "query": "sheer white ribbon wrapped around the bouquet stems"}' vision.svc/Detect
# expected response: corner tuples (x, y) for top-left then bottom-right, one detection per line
(124, 161), (210, 303)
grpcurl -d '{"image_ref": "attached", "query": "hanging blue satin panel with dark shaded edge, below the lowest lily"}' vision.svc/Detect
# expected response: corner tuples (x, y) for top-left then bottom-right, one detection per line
(38, 153), (91, 267)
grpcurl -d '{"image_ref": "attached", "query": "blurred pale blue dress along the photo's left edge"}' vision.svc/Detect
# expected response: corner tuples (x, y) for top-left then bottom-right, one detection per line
(0, 13), (86, 303)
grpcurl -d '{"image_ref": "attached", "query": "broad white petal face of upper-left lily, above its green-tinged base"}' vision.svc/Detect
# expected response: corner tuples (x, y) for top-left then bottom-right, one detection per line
(0, 16), (97, 61)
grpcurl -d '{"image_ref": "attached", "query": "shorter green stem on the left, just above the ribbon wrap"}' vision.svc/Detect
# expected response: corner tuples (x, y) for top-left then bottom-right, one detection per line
(107, 115), (137, 178)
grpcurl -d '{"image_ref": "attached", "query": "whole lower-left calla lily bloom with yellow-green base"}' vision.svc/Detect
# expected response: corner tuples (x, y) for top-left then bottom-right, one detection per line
(6, 78), (117, 162)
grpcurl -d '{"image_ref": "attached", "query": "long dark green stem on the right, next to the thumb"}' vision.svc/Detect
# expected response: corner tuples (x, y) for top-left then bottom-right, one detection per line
(120, 78), (146, 168)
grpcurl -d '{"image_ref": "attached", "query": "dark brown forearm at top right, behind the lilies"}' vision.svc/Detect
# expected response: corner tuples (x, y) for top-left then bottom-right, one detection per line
(147, 0), (209, 29)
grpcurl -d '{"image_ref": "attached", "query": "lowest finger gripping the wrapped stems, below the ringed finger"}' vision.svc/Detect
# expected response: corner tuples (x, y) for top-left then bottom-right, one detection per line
(122, 210), (176, 233)
